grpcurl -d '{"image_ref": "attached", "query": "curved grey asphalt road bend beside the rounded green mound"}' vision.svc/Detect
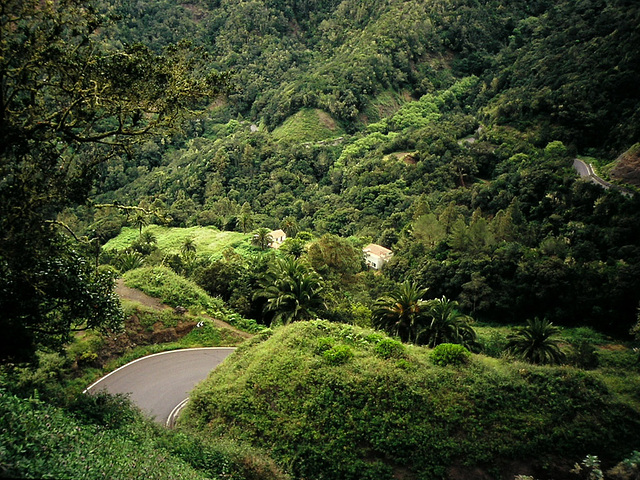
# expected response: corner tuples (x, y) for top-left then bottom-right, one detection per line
(85, 347), (235, 426)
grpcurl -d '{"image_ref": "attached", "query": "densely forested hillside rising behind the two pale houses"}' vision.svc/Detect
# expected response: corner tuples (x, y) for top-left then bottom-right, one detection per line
(76, 1), (640, 335)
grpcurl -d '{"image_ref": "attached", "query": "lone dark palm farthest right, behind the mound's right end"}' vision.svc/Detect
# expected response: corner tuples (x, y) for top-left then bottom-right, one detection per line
(507, 317), (565, 365)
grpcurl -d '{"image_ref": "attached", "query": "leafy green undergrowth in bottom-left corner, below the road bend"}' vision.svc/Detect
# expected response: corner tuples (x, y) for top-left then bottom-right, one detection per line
(0, 376), (287, 480)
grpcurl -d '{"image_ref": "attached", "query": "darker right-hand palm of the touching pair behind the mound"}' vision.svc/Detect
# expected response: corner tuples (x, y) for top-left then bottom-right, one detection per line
(416, 297), (477, 350)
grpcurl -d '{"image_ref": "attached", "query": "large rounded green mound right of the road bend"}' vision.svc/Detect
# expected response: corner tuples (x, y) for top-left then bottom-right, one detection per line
(182, 321), (640, 479)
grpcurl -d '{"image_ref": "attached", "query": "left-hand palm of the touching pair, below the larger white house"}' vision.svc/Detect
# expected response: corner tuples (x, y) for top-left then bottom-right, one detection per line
(372, 280), (428, 342)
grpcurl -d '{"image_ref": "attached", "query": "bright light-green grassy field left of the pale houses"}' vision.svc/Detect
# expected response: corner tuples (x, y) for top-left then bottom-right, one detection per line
(104, 225), (249, 256)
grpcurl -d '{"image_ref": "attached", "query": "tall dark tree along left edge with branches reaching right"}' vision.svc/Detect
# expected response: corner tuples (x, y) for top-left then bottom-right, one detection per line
(0, 0), (222, 362)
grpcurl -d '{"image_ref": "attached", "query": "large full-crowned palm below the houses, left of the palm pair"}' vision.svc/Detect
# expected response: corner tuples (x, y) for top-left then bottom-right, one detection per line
(255, 257), (324, 325)
